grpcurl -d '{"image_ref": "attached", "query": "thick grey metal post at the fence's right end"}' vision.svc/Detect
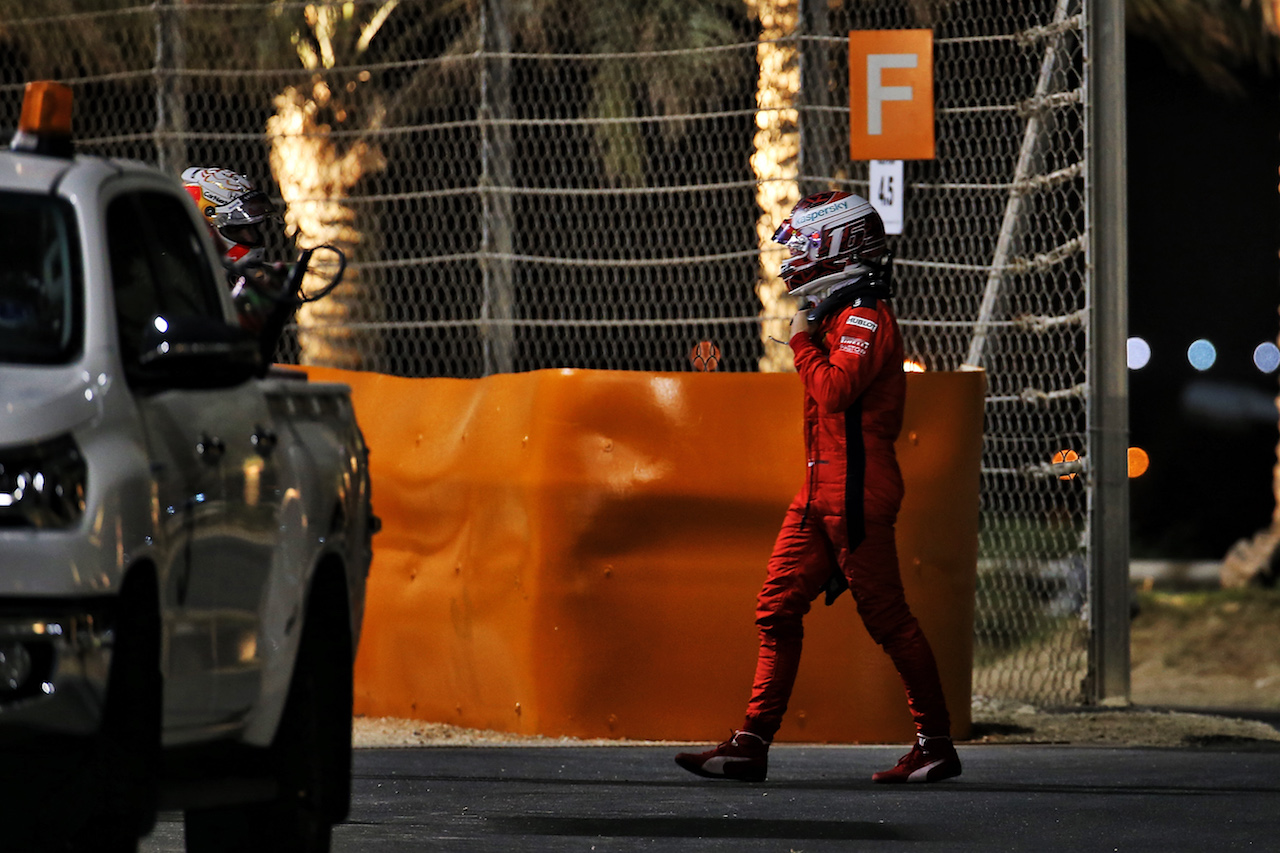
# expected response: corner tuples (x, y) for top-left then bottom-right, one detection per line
(1085, 0), (1129, 703)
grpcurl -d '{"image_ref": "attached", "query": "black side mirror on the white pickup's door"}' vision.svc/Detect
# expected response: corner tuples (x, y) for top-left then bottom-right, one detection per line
(127, 316), (262, 391)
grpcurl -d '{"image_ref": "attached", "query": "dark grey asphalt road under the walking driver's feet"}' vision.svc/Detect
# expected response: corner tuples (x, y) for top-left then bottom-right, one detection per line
(141, 744), (1280, 853)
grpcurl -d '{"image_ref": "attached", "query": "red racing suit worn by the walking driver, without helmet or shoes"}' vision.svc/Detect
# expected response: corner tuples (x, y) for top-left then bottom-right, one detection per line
(744, 295), (951, 740)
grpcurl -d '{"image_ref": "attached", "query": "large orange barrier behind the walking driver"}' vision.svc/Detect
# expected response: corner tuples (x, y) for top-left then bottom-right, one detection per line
(310, 369), (984, 743)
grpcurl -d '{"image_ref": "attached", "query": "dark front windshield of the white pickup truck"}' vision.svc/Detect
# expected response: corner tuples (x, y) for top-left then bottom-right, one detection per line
(0, 192), (82, 364)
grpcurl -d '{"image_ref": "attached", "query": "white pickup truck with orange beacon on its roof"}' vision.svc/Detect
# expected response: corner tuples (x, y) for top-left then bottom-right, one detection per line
(0, 85), (378, 853)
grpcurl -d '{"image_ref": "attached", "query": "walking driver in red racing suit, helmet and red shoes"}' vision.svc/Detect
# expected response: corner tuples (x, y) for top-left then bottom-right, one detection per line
(676, 192), (960, 783)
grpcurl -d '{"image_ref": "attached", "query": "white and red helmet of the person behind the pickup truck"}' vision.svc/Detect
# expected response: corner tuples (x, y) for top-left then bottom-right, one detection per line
(182, 167), (280, 269)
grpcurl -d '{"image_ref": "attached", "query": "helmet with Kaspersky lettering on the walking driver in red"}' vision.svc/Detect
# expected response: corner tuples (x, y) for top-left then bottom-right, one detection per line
(773, 191), (890, 298)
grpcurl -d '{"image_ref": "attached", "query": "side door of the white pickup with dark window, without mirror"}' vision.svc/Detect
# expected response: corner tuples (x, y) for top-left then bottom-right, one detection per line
(108, 191), (280, 730)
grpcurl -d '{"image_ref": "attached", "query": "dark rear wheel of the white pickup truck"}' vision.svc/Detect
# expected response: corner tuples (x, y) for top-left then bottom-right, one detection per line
(186, 581), (352, 853)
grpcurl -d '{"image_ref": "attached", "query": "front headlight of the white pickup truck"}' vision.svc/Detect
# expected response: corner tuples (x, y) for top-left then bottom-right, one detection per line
(0, 435), (88, 528)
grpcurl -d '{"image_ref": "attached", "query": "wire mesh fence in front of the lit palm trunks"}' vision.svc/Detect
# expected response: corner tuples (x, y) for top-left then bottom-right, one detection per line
(0, 0), (1089, 704)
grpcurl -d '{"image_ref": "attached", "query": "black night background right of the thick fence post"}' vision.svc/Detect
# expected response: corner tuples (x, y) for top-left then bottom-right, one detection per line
(1126, 36), (1280, 560)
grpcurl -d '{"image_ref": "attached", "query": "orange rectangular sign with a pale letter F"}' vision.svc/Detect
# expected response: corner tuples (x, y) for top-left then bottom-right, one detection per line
(849, 29), (934, 160)
